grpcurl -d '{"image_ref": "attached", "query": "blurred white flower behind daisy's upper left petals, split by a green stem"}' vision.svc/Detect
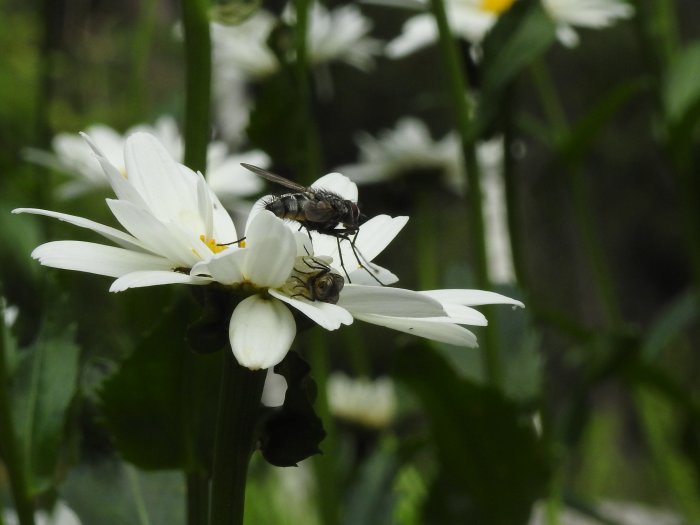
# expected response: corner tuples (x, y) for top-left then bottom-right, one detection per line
(25, 116), (270, 203)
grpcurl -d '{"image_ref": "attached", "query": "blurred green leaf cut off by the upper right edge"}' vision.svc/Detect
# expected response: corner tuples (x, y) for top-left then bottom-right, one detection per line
(662, 41), (700, 126)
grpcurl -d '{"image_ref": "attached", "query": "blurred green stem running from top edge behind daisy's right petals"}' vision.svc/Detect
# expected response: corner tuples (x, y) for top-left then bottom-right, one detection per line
(431, 0), (503, 385)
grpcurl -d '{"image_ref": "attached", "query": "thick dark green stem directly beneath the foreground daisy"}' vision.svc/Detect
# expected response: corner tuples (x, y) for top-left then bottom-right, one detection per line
(209, 350), (266, 525)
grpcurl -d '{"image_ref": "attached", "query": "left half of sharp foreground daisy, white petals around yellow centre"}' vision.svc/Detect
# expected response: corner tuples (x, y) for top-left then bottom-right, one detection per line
(13, 132), (238, 292)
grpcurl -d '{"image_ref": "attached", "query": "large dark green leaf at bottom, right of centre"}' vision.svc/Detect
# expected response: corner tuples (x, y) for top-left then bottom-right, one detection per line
(398, 345), (549, 525)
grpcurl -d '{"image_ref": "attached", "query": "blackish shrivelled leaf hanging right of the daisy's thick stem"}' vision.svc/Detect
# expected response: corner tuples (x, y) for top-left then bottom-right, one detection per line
(260, 352), (326, 467)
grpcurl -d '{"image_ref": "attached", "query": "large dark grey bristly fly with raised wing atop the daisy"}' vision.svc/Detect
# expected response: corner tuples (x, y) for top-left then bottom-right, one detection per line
(241, 163), (384, 286)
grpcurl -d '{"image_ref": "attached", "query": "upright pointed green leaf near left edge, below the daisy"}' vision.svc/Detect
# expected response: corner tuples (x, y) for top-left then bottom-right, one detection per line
(12, 326), (80, 494)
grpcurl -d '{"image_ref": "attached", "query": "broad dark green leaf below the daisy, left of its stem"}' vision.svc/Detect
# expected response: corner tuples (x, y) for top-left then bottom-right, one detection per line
(99, 296), (222, 471)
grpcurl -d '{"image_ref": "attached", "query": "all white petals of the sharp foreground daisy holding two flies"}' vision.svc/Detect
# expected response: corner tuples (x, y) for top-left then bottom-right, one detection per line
(14, 133), (522, 369)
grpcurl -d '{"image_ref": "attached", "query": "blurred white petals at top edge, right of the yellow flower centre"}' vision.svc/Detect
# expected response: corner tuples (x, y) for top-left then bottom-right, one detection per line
(542, 0), (634, 47)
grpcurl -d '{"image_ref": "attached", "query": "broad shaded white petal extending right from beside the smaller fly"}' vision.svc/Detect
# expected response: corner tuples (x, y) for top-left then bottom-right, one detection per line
(338, 284), (446, 317)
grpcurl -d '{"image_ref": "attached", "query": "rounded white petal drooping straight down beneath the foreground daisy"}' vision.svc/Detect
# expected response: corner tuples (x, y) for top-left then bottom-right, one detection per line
(229, 295), (296, 370)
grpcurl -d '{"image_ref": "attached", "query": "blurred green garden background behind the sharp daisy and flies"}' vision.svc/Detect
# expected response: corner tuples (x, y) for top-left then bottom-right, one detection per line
(0, 0), (700, 525)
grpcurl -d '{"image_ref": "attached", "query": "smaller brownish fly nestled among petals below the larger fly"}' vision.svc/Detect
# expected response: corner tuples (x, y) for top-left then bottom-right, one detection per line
(285, 255), (345, 304)
